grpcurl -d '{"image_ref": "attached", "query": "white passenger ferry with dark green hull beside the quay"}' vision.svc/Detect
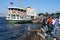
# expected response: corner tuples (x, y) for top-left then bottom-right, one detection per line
(6, 7), (36, 24)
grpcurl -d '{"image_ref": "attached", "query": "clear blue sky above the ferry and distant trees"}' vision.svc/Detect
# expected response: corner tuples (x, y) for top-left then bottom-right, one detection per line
(0, 0), (60, 14)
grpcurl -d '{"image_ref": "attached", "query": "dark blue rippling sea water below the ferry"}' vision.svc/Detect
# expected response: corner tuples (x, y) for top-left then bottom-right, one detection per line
(0, 17), (38, 40)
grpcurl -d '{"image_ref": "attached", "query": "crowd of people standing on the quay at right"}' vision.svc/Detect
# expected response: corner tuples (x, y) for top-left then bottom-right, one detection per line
(39, 15), (60, 37)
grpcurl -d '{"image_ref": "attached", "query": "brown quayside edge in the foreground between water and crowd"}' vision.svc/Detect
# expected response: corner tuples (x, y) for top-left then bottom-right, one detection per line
(18, 27), (56, 40)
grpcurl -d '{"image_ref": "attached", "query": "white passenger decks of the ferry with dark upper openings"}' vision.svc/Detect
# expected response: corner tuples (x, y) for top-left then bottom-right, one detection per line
(7, 7), (30, 20)
